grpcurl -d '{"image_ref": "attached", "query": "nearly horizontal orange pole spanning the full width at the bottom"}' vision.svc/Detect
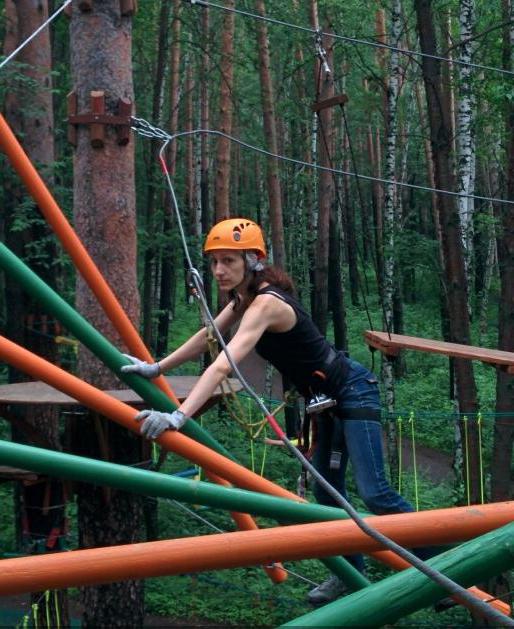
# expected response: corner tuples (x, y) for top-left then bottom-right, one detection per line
(0, 502), (514, 595)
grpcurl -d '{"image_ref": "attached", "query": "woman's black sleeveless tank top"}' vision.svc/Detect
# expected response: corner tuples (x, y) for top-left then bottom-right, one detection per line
(255, 286), (348, 396)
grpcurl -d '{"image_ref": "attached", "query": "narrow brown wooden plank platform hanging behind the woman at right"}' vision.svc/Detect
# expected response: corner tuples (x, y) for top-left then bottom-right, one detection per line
(364, 330), (514, 374)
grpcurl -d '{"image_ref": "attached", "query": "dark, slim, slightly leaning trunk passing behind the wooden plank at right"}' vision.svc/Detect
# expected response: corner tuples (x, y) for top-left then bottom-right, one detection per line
(415, 0), (480, 501)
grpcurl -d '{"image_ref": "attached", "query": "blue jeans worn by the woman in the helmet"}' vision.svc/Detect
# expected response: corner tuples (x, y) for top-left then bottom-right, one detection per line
(313, 360), (414, 571)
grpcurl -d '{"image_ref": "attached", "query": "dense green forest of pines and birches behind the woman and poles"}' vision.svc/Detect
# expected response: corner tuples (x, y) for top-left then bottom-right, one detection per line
(0, 0), (514, 626)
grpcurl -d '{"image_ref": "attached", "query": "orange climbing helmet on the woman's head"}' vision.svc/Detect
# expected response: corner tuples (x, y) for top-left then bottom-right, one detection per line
(203, 218), (266, 258)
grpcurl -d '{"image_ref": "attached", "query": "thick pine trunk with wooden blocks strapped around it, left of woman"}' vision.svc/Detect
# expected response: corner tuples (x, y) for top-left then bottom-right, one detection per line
(70, 0), (144, 627)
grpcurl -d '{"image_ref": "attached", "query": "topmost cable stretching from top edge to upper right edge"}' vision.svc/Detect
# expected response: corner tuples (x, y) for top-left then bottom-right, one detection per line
(183, 0), (514, 76)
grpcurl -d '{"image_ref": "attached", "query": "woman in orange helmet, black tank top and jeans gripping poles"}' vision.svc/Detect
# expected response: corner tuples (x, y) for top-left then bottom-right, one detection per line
(122, 218), (413, 604)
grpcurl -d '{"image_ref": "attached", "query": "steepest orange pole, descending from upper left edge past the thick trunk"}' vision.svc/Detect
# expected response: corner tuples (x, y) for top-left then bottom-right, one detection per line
(0, 113), (287, 582)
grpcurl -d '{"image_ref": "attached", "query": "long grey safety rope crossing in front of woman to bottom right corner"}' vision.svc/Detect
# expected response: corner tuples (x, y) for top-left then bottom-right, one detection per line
(132, 119), (514, 627)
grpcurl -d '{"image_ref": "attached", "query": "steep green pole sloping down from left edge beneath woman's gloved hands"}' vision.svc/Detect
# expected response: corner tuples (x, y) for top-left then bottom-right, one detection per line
(0, 243), (369, 589)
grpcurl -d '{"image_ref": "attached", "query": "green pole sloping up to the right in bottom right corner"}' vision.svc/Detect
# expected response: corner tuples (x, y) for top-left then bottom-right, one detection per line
(282, 523), (514, 627)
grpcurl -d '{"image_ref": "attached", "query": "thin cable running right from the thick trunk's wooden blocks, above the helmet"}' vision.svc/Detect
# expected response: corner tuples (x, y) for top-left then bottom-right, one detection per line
(132, 118), (514, 210)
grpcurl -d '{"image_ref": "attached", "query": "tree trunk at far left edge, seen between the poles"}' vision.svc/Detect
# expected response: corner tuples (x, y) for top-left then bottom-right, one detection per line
(3, 0), (69, 626)
